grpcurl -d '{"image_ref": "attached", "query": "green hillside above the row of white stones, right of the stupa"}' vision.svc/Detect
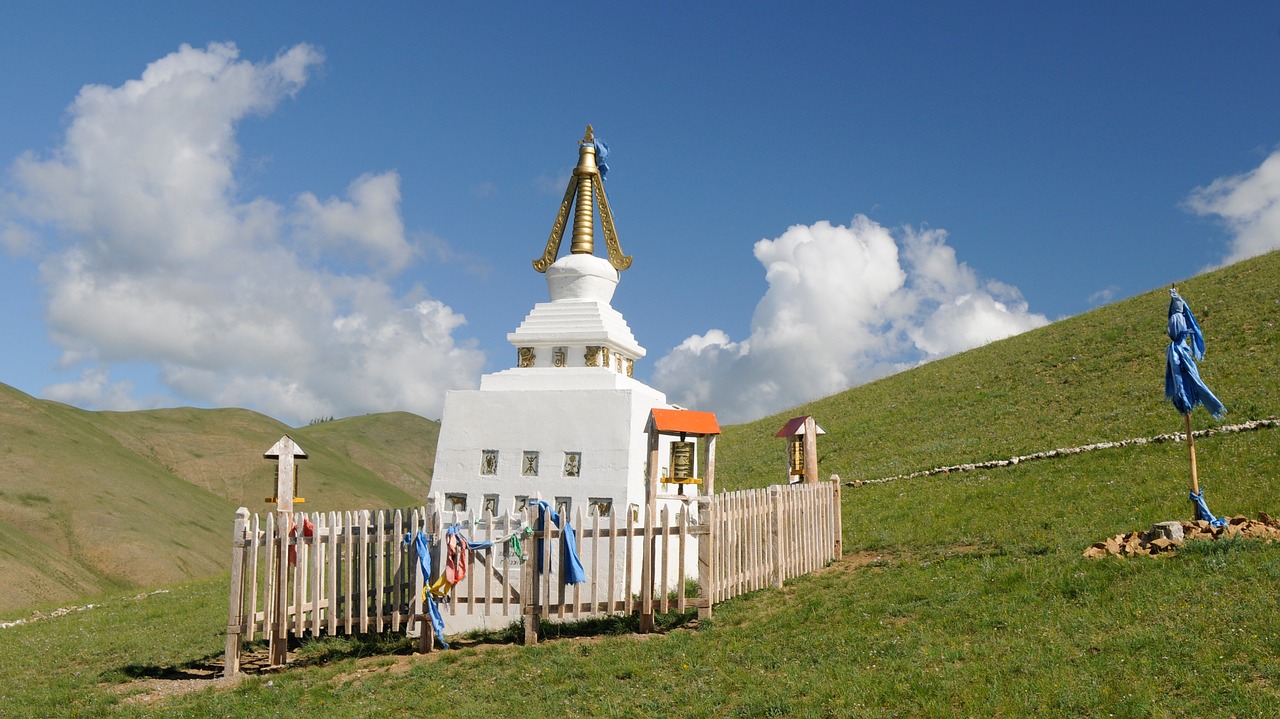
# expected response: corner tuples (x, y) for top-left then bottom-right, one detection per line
(717, 245), (1280, 489)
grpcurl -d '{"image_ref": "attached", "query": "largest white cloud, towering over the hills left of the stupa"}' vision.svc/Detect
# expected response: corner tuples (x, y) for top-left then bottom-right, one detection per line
(0, 43), (483, 422)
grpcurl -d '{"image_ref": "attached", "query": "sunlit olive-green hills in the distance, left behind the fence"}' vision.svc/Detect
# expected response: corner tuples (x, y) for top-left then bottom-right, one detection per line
(0, 384), (439, 610)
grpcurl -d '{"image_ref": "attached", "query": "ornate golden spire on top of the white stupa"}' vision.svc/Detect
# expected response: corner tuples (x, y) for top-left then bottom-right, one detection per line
(534, 125), (631, 273)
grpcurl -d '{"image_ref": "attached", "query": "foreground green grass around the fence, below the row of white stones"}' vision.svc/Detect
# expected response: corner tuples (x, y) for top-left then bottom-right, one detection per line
(0, 432), (1280, 718)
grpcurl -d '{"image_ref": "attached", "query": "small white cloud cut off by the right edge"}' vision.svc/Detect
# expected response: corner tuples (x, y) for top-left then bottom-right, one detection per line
(1187, 151), (1280, 265)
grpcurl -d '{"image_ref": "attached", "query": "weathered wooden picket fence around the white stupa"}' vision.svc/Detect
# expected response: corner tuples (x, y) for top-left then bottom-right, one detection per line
(225, 482), (841, 674)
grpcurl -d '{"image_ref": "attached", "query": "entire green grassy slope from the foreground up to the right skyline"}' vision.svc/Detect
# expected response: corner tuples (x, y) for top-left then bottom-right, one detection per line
(0, 253), (1280, 718)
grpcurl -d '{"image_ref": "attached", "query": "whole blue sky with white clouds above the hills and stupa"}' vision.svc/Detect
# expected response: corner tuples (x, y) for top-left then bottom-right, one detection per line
(0, 3), (1280, 423)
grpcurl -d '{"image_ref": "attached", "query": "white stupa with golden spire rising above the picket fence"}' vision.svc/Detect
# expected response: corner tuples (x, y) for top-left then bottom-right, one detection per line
(431, 125), (669, 519)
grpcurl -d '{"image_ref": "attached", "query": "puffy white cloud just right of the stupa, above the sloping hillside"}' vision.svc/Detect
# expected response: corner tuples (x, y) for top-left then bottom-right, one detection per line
(654, 215), (1048, 422)
